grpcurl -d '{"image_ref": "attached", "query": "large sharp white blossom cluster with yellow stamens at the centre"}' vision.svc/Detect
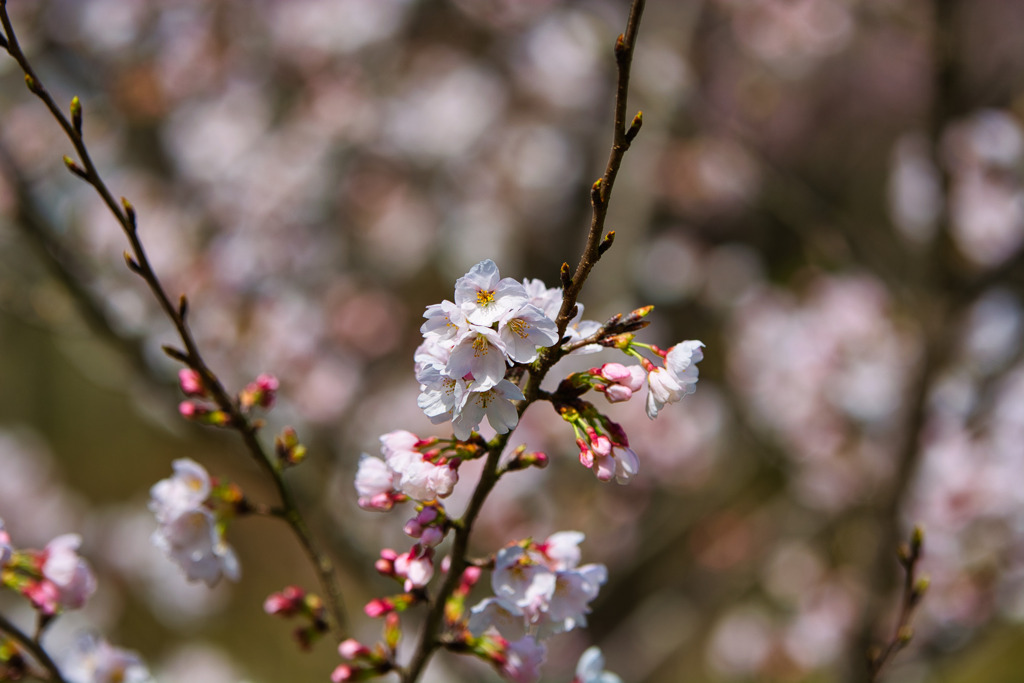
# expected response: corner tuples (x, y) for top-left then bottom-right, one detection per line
(415, 259), (561, 439)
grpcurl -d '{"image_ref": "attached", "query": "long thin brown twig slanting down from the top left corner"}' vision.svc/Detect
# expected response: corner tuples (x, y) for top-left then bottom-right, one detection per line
(0, 0), (346, 640)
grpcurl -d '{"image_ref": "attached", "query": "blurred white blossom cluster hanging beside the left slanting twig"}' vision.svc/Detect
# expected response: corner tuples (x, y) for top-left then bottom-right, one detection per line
(150, 458), (240, 586)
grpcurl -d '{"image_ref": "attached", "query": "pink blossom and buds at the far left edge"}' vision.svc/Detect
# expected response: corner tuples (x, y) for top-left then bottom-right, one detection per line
(0, 519), (96, 618)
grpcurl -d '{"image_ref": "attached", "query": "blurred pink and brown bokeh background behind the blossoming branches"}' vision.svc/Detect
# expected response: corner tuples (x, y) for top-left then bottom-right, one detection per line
(0, 0), (1024, 683)
